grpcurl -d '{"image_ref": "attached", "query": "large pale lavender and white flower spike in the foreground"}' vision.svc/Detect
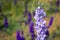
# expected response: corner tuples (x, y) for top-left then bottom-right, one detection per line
(34, 7), (48, 40)
